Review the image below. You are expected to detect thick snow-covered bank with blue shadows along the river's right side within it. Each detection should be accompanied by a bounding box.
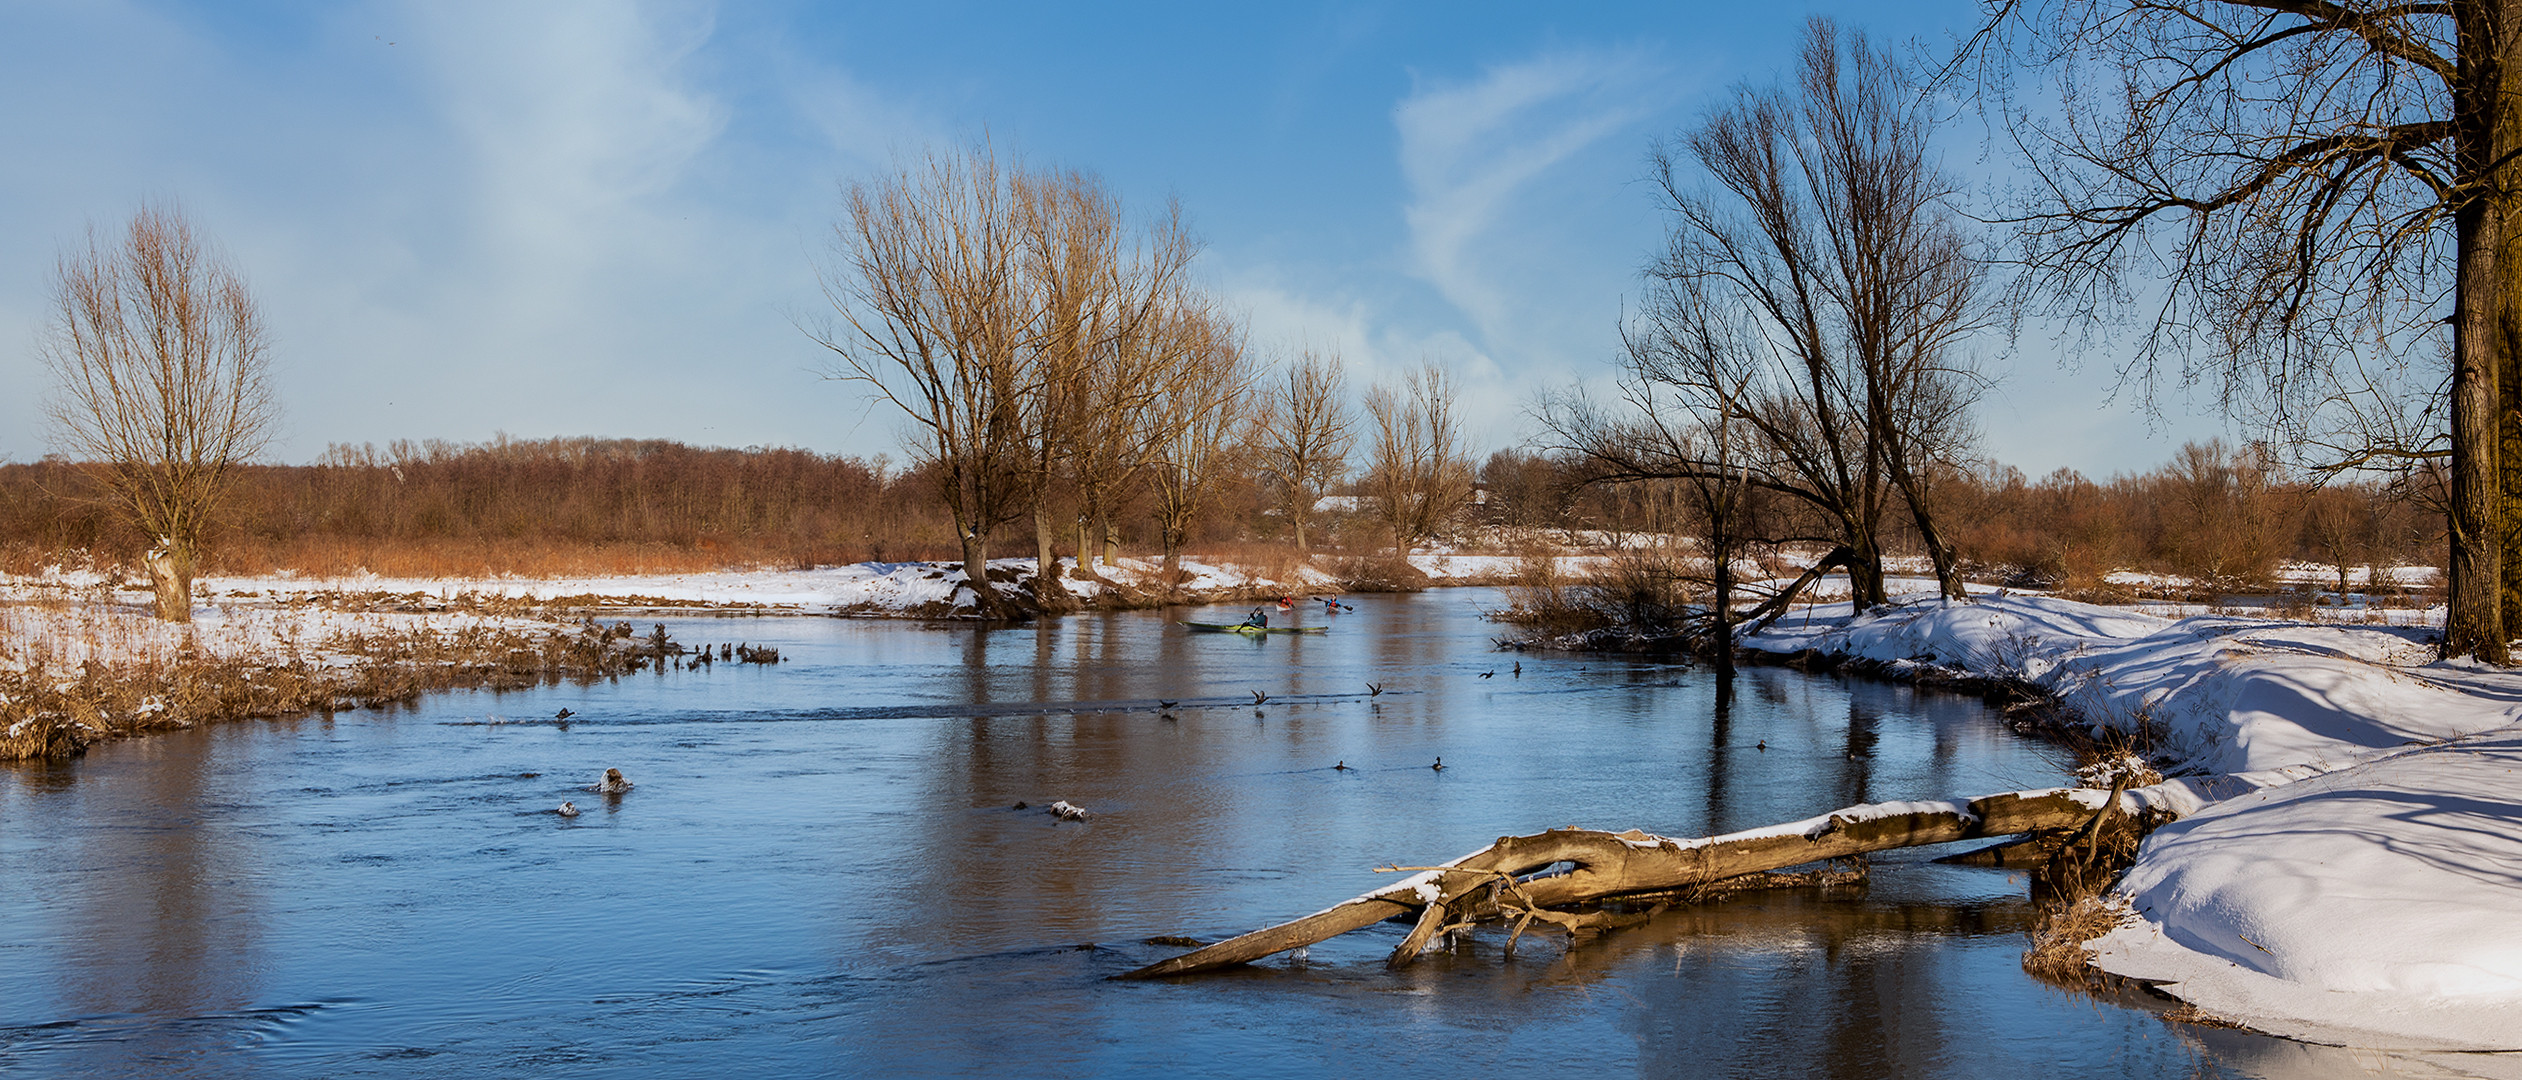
[1745,596,2522,1050]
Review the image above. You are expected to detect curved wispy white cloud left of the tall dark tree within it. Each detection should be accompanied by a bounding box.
[1392,50,1672,346]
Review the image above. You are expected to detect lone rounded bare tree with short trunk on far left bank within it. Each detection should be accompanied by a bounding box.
[40,204,280,623]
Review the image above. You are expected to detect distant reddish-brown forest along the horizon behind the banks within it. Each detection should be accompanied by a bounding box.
[0,439,2444,590]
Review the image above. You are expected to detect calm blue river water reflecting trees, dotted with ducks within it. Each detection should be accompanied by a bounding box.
[0,590,2371,1080]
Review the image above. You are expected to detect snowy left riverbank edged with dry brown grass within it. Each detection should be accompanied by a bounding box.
[0,553,1518,762]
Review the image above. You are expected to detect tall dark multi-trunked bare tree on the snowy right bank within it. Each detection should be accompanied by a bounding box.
[1593,20,1985,608]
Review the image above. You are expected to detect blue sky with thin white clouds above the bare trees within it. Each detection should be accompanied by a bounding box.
[0,0,2219,474]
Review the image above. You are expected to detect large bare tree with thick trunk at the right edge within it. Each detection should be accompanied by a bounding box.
[1975,0,2522,664]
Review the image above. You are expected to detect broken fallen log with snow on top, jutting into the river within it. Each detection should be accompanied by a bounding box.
[1117,785,2192,979]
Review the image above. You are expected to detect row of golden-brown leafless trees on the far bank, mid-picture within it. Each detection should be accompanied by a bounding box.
[812,144,1470,616]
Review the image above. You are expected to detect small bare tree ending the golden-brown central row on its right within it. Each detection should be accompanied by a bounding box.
[1364,361,1470,558]
